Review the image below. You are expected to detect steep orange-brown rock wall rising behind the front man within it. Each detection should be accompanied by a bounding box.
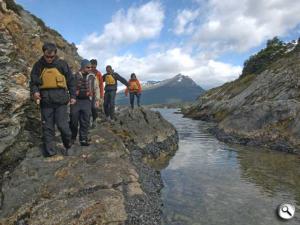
[0,0,80,154]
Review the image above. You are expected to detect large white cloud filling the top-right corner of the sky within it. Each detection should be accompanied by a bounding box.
[185,0,300,52]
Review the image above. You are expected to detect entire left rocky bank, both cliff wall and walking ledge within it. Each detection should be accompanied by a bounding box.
[0,0,178,225]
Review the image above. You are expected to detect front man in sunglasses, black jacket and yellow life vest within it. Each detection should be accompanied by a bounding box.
[30,42,76,157]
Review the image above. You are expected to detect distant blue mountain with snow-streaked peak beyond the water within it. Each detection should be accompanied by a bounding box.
[116,74,204,105]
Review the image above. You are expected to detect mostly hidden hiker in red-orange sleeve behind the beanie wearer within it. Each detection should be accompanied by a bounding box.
[90,59,104,128]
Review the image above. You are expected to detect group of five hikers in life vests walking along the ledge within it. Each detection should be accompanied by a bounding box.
[30,42,142,157]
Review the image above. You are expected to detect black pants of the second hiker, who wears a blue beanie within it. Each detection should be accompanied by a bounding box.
[70,99,91,141]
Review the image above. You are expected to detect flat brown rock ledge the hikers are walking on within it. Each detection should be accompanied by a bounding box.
[0,108,178,225]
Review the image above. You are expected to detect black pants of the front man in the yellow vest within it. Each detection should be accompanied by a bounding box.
[41,105,71,156]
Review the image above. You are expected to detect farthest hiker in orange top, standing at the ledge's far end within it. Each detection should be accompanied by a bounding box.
[125,73,142,109]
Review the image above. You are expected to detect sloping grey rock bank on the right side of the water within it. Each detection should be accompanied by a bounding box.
[183,40,300,153]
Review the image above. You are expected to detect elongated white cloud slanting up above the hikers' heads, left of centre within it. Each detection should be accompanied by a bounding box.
[77,1,164,58]
